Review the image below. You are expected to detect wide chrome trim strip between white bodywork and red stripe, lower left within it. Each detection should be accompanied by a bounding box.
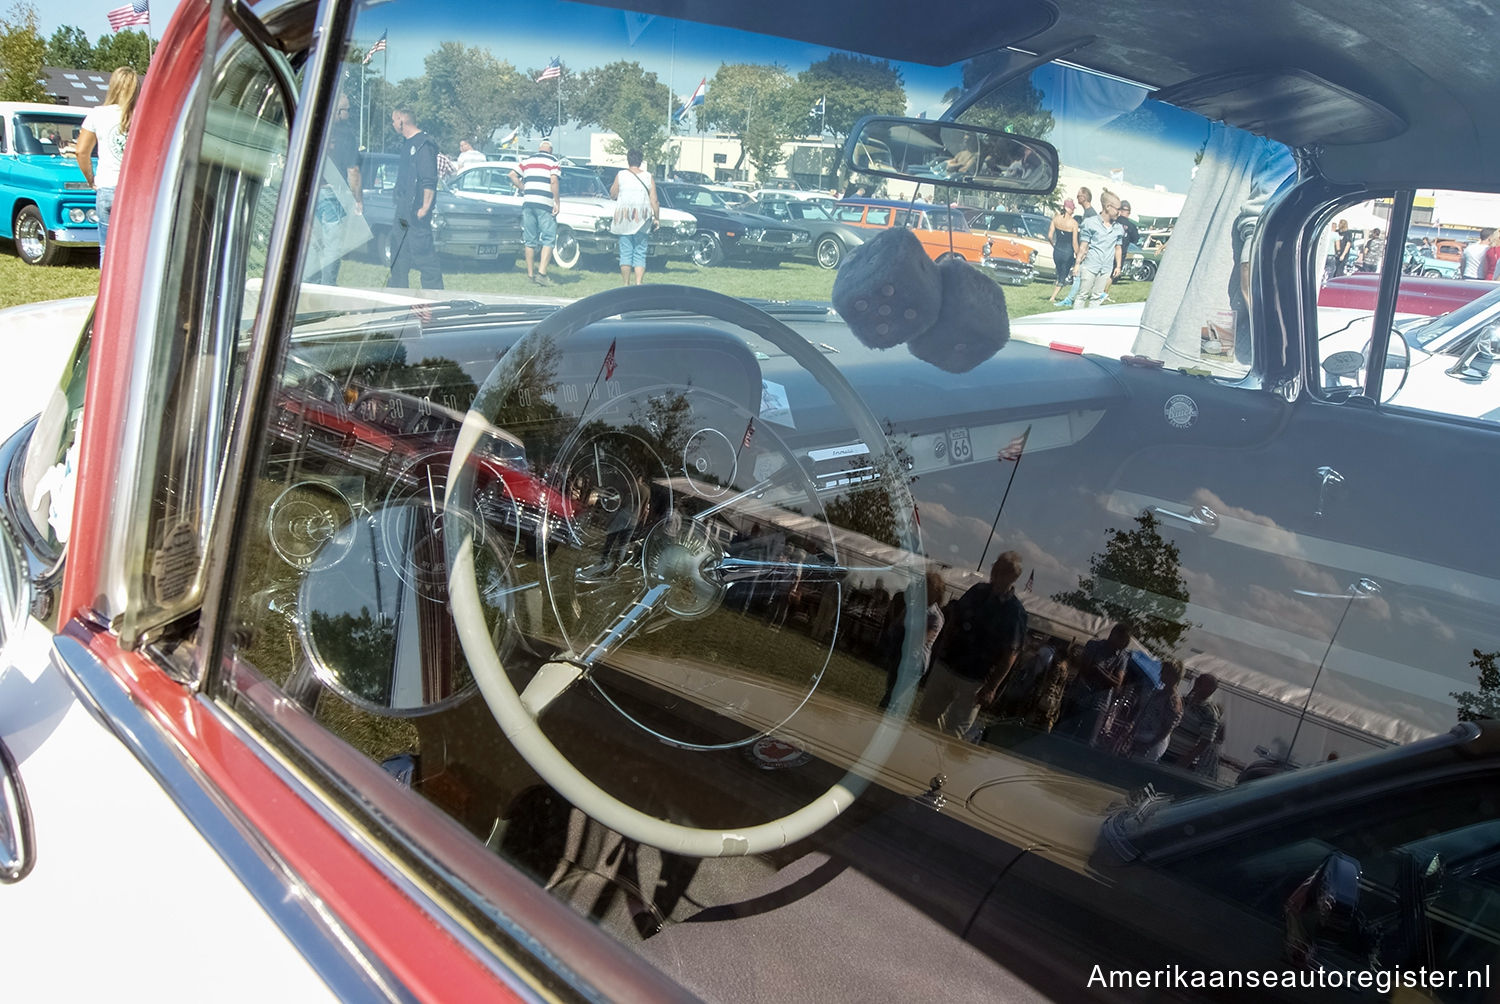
[51,636,417,1001]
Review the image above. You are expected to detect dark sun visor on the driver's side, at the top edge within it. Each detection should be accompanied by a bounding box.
[579,0,1058,66]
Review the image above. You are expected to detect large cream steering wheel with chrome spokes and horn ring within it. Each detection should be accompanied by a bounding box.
[434,285,926,857]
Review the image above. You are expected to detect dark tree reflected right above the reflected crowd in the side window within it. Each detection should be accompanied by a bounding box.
[1052,512,1191,656]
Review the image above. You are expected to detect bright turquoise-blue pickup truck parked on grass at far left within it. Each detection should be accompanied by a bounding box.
[0,102,99,266]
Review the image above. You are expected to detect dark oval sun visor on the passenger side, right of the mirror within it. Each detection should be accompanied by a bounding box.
[1152,69,1407,147]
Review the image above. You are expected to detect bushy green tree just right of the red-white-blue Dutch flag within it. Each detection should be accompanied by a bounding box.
[699,63,812,182]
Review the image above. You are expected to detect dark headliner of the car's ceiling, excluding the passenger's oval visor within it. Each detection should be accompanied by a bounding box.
[582,0,1500,191]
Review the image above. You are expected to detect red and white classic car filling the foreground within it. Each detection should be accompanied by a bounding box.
[0,0,1500,1002]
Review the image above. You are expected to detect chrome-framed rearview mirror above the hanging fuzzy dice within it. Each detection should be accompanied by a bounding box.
[843,116,1058,195]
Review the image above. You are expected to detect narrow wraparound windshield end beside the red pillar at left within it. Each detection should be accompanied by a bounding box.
[102,41,297,644]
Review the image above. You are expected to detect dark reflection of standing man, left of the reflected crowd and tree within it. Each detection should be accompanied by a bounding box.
[918,551,1026,738]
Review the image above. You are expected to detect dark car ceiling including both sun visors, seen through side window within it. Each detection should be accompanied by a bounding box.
[582,0,1476,191]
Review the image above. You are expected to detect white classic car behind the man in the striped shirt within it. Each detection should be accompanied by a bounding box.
[447,164,698,269]
